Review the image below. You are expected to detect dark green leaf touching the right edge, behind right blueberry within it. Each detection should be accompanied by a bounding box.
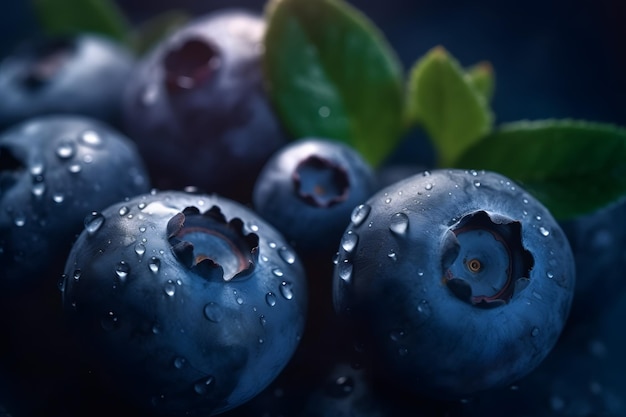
[450,120,626,219]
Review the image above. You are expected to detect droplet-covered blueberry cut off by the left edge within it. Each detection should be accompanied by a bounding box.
[0,115,150,292]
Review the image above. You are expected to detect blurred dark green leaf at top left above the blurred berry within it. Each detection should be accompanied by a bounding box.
[32,0,130,42]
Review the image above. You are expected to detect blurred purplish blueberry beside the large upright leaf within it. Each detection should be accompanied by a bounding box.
[123,9,285,204]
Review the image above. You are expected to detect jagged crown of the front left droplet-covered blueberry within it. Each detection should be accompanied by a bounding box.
[167,206,259,281]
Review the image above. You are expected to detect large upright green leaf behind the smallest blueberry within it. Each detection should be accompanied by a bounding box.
[264,0,405,165]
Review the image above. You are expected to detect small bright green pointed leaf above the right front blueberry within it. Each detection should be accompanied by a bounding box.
[408,46,493,167]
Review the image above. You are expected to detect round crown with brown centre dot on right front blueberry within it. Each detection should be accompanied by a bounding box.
[443,210,534,308]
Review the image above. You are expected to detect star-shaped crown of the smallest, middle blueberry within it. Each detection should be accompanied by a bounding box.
[292,155,350,207]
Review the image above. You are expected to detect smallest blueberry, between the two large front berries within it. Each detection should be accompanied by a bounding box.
[252,138,376,255]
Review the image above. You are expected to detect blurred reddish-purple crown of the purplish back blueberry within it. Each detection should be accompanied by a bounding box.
[163,38,220,94]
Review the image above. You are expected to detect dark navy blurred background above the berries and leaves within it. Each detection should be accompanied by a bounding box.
[0,0,626,125]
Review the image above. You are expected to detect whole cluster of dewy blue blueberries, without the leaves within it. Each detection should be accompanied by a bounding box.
[0,6,626,417]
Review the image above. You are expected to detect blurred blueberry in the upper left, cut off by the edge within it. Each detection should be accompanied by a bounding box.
[0,34,135,129]
